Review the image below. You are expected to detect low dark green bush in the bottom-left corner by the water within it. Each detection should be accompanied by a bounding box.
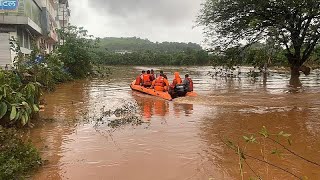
[0,126,42,180]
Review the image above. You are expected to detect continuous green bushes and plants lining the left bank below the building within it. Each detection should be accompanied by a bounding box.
[0,26,103,179]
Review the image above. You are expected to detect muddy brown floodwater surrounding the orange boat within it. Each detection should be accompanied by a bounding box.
[29,67,320,180]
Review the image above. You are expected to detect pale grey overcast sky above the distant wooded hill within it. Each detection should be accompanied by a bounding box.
[69,0,204,43]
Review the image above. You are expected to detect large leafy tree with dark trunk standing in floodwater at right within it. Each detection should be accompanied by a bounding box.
[197,0,320,82]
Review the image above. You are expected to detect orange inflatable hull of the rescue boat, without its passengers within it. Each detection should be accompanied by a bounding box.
[130,81,197,101]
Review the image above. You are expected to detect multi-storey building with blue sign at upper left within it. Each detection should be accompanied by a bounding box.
[0,0,70,68]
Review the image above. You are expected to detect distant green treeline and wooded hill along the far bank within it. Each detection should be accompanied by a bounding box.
[92,37,320,67]
